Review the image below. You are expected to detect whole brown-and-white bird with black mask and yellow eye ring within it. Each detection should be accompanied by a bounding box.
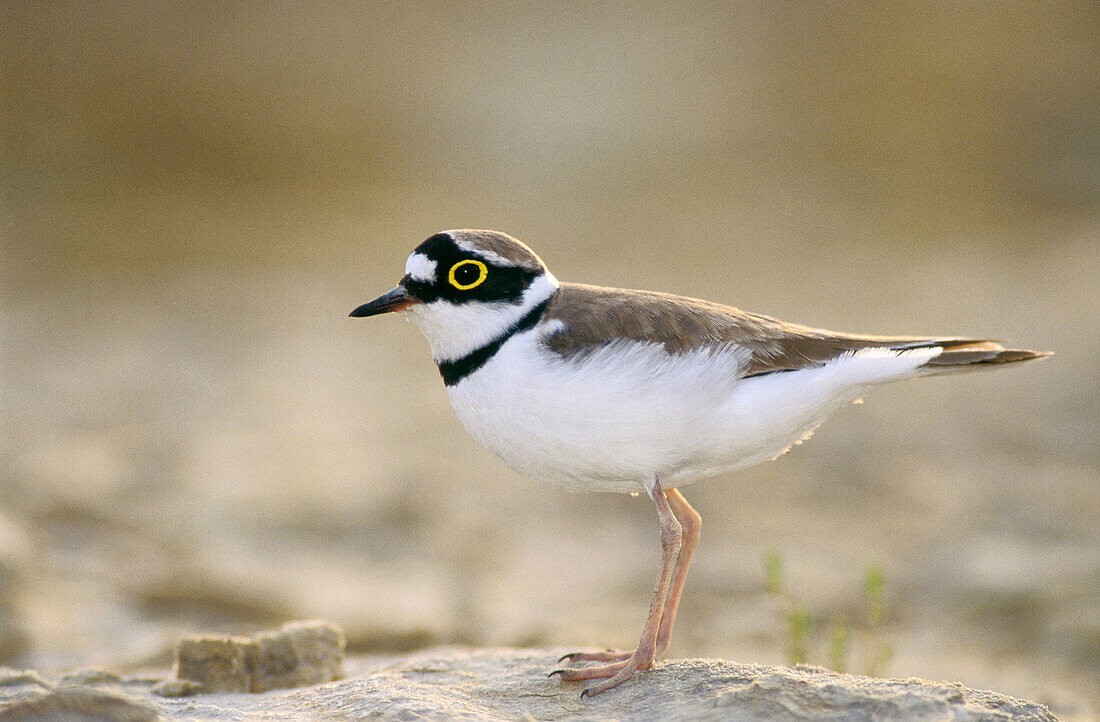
[350,230,1051,698]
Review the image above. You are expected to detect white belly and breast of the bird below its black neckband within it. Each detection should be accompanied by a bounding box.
[448,334,942,492]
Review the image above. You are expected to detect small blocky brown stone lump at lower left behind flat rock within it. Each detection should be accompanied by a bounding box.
[172,621,344,692]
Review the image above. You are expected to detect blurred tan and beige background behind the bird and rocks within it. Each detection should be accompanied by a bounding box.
[0,2,1100,719]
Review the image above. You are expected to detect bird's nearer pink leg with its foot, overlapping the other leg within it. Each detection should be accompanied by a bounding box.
[550,488,683,698]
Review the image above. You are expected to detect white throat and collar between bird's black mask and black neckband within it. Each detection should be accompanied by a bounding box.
[408,273,558,362]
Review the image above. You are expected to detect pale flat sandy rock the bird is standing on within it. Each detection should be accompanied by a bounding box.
[0,649,1055,722]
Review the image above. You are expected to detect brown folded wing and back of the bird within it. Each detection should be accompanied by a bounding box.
[543,283,1001,376]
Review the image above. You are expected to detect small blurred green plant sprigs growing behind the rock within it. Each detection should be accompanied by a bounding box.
[763,550,893,677]
